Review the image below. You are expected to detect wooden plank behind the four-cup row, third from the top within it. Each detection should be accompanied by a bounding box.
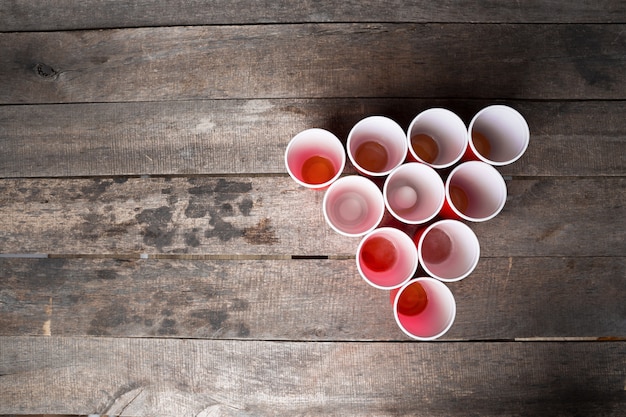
[0,99,626,178]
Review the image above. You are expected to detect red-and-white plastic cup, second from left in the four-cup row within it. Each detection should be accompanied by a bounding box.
[347,116,407,177]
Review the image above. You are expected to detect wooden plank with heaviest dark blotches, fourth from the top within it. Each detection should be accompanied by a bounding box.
[0,177,626,257]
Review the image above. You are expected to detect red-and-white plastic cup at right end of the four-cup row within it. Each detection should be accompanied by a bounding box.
[465,105,530,166]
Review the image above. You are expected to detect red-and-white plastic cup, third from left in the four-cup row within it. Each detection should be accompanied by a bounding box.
[406,108,467,169]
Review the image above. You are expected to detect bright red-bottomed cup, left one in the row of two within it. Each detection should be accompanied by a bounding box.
[356,227,418,290]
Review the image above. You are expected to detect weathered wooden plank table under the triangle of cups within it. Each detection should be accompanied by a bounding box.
[0,0,626,416]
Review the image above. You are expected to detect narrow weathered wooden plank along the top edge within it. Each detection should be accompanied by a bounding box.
[0,0,626,31]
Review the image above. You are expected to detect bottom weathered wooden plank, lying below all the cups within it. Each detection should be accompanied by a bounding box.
[0,337,626,416]
